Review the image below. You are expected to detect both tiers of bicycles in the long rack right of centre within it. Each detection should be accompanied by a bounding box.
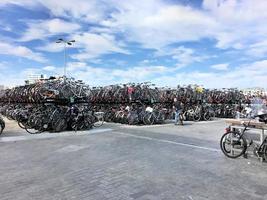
[89,82,253,124]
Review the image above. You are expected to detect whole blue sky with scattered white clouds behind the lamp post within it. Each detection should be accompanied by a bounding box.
[0,0,267,88]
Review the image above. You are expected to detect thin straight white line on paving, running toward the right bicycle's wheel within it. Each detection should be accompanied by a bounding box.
[114,131,221,152]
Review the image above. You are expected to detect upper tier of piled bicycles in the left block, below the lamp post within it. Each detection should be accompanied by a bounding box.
[0,77,90,103]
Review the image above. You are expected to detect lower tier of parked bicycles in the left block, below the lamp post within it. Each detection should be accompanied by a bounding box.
[1,103,103,134]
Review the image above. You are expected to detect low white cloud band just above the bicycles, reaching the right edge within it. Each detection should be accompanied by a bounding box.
[152,60,267,88]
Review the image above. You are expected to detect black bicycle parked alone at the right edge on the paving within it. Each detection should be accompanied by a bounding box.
[220,120,267,161]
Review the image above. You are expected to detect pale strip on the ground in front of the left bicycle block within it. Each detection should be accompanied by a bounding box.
[0,128,113,142]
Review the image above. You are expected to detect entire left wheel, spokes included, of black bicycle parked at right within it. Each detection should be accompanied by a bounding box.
[220,131,247,158]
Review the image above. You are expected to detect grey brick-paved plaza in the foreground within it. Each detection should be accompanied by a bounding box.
[0,120,267,200]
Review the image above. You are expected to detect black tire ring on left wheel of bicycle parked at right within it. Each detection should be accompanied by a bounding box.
[220,131,247,159]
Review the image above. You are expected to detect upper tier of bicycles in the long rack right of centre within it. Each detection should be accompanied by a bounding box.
[89,82,253,105]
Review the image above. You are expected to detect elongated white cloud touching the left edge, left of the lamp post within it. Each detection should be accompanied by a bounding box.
[0,42,47,62]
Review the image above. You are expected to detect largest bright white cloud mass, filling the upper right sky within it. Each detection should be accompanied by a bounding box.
[103,0,267,53]
